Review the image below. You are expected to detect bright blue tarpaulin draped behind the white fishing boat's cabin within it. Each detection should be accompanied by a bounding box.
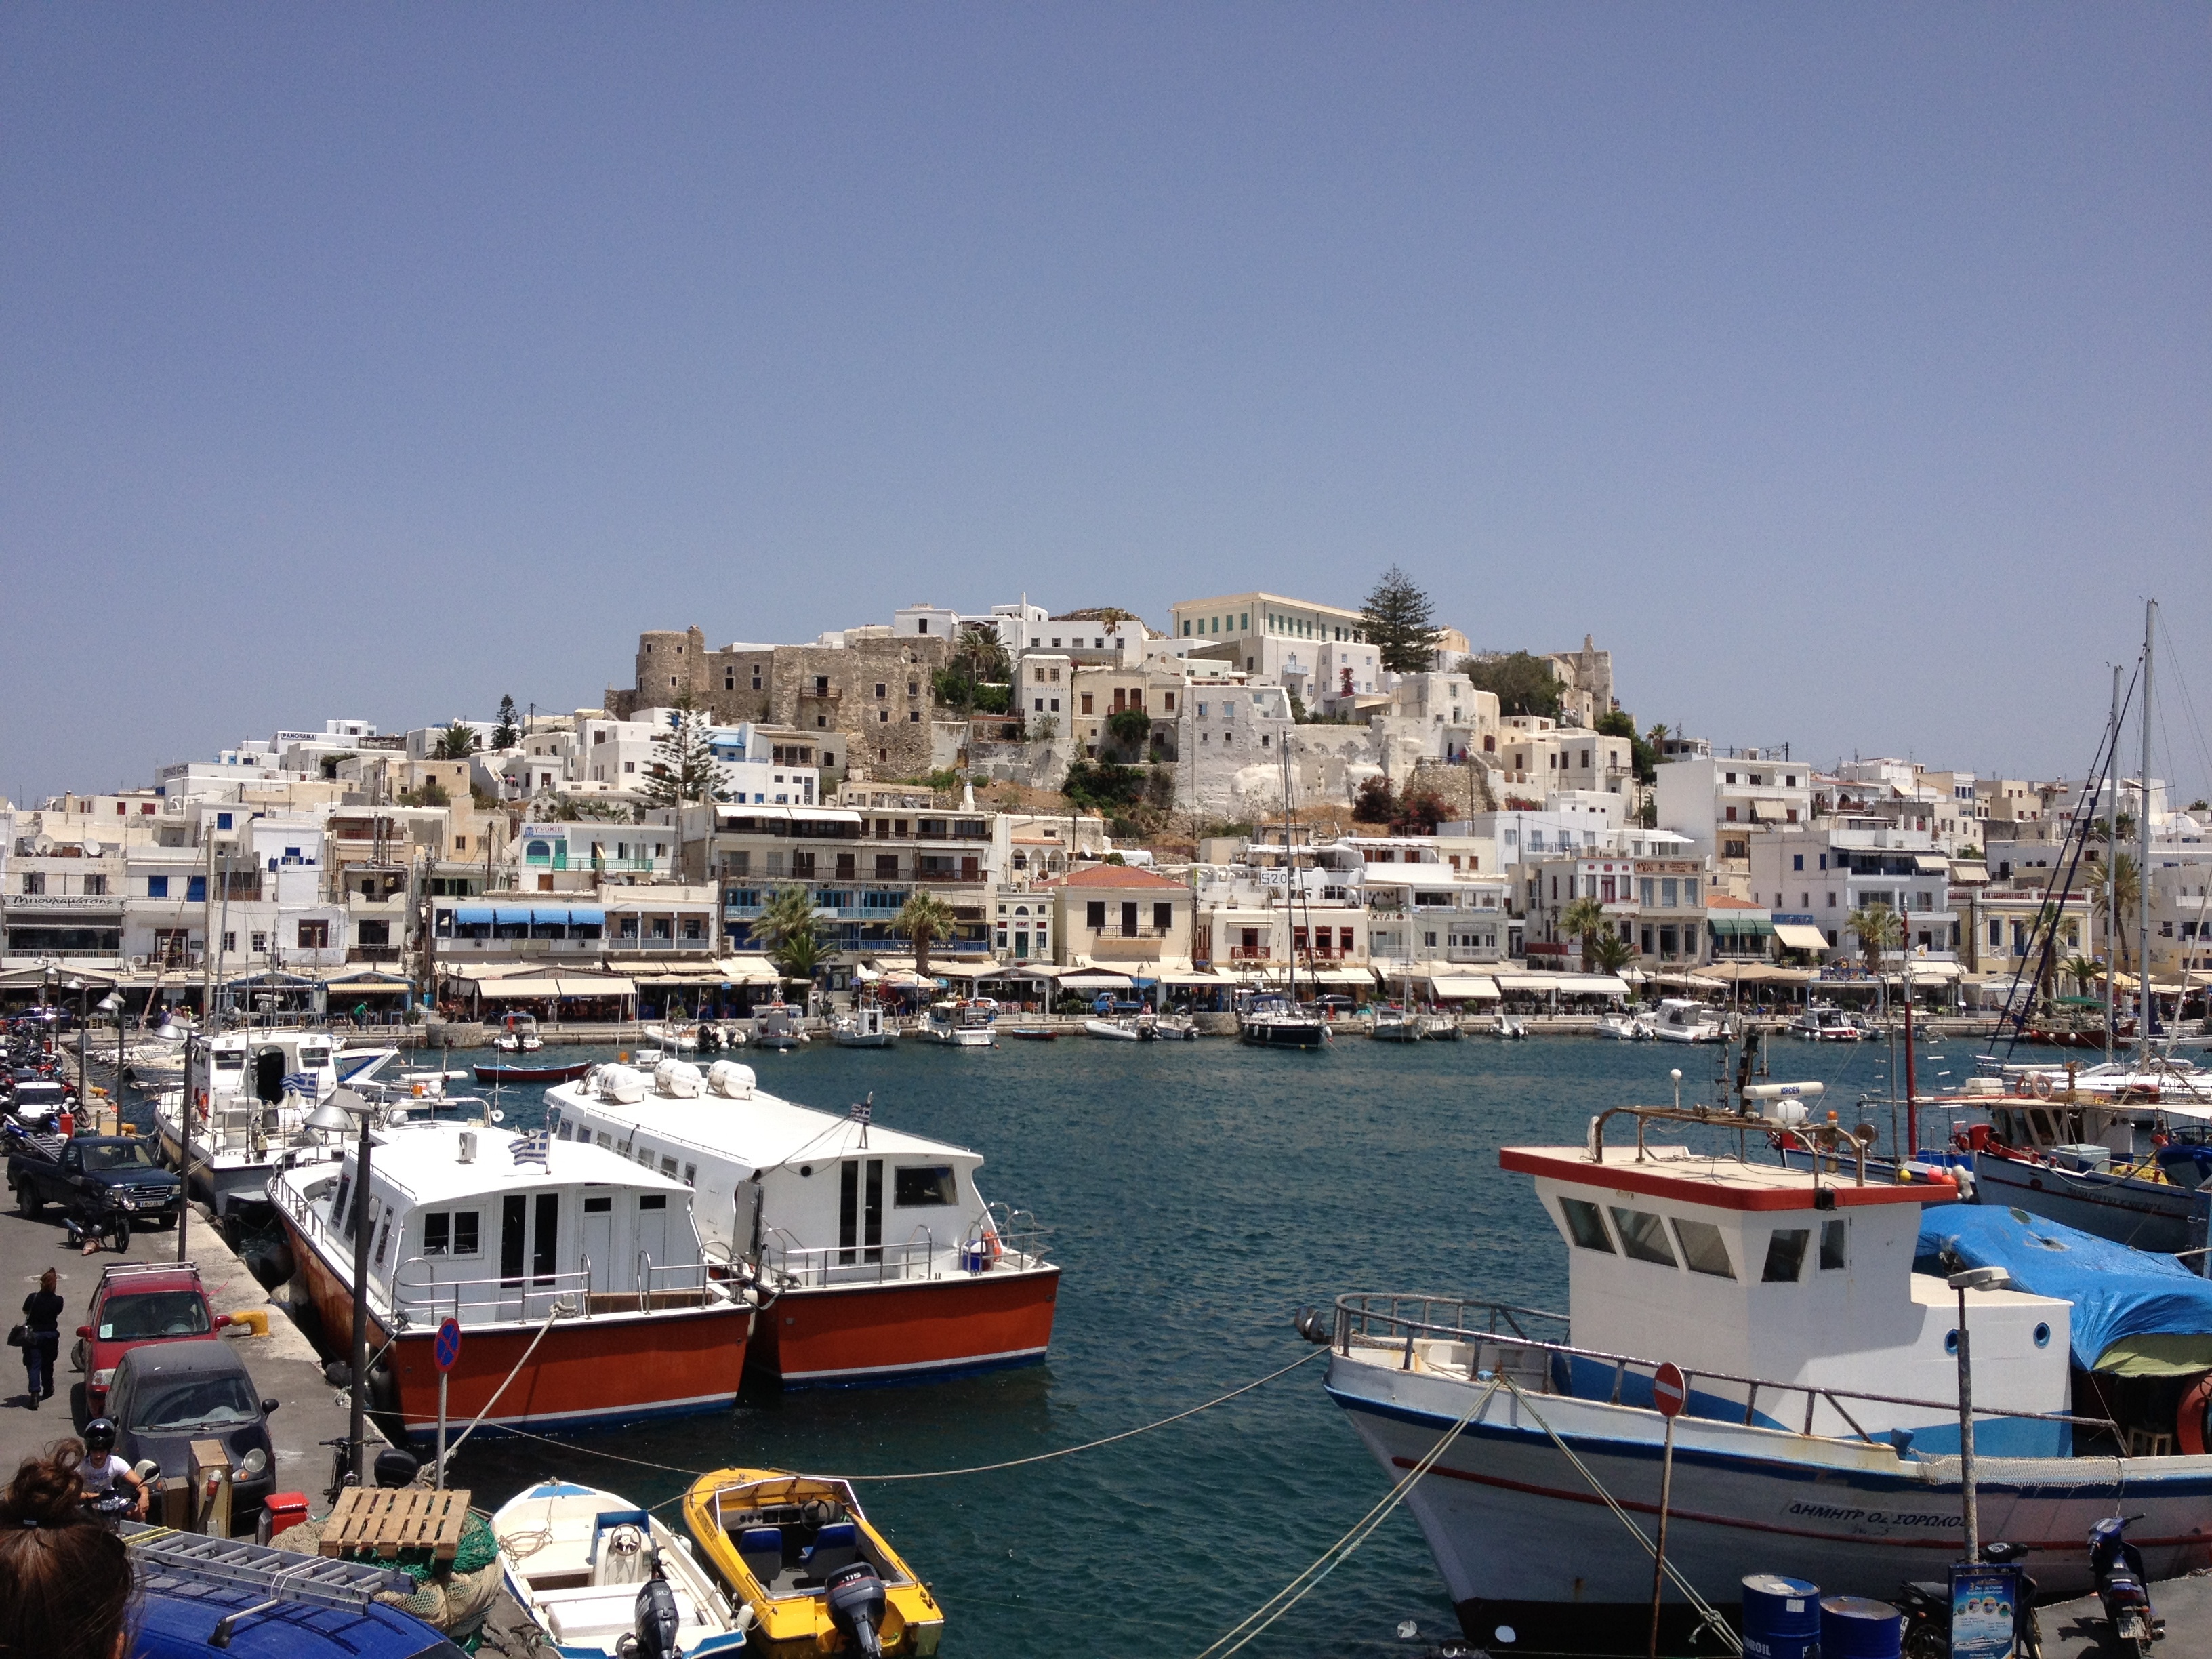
[1918,1204,2212,1376]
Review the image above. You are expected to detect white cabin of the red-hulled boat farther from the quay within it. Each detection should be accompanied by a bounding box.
[546,1059,1017,1288]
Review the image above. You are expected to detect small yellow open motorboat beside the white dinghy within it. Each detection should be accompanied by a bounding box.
[684,1469,945,1659]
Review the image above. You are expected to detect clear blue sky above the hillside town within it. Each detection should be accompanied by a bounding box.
[0,5,2212,801]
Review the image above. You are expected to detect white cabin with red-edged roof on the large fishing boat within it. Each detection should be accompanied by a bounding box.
[1500,1146,2072,1456]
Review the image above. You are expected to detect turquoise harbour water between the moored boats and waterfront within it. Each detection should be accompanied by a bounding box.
[298,1038,1880,1659]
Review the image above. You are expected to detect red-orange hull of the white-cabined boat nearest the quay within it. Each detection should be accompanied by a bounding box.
[285,1218,752,1433]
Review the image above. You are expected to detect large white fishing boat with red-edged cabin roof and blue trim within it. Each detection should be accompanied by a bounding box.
[1323,1108,2212,1652]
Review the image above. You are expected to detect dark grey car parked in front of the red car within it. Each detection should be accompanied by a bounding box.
[108,1343,276,1533]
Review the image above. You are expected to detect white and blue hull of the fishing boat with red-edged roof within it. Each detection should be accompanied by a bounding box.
[1327,1356,2212,1654]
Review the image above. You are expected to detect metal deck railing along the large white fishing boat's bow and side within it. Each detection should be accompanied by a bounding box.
[1332,1292,2119,1444]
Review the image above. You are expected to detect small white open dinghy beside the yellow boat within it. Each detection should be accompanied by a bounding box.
[491,1480,752,1659]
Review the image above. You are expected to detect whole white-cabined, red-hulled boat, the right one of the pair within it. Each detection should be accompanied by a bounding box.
[546,1059,1059,1387]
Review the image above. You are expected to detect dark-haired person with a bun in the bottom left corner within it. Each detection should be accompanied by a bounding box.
[0,1440,131,1659]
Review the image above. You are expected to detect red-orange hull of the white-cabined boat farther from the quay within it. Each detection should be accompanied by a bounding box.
[752,1267,1059,1382]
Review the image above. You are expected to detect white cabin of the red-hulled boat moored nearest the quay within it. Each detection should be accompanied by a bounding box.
[291,1122,705,1325]
